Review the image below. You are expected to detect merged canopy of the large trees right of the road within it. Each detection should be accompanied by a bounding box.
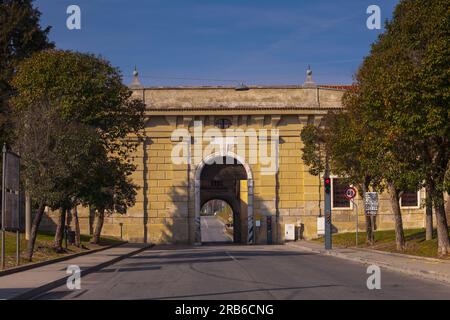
[304,0,450,255]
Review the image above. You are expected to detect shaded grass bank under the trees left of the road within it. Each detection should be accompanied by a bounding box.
[0,232,122,268]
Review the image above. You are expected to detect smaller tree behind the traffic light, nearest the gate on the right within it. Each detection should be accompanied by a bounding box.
[302,83,421,250]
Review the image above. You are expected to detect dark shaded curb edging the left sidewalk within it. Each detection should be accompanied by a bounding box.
[9,244,154,300]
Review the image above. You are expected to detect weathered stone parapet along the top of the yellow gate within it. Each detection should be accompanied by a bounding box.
[132,85,351,110]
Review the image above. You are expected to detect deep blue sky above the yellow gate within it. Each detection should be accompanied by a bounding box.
[35,0,398,86]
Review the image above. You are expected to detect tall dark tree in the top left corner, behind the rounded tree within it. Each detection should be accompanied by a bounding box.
[0,0,53,145]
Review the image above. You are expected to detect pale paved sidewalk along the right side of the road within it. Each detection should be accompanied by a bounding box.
[287,241,450,284]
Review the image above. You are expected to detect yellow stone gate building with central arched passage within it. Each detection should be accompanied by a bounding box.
[40,72,425,244]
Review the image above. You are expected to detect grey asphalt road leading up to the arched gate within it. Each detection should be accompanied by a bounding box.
[39,245,450,300]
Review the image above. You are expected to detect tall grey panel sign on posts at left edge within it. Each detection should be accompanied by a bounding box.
[1,144,20,269]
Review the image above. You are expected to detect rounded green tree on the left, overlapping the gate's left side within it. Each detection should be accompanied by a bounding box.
[11,50,145,257]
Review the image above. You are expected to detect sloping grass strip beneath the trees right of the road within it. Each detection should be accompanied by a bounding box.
[314,229,450,259]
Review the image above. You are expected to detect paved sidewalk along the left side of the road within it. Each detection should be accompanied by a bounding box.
[0,243,151,300]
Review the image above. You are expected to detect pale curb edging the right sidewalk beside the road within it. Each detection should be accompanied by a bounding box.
[293,245,450,284]
